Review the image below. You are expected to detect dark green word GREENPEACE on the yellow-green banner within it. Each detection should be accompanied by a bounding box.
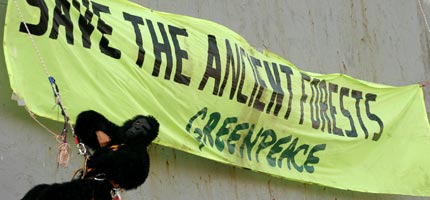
[185,107,326,173]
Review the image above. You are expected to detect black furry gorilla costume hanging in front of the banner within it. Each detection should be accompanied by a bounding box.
[23,110,159,200]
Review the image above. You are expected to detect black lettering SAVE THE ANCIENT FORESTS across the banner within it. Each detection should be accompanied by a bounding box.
[19,0,384,141]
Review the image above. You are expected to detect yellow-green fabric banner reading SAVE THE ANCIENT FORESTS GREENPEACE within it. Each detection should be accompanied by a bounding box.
[4,0,430,196]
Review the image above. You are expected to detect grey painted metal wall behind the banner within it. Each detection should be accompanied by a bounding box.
[0,0,430,200]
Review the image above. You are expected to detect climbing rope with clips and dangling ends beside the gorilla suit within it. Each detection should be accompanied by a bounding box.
[13,0,89,167]
